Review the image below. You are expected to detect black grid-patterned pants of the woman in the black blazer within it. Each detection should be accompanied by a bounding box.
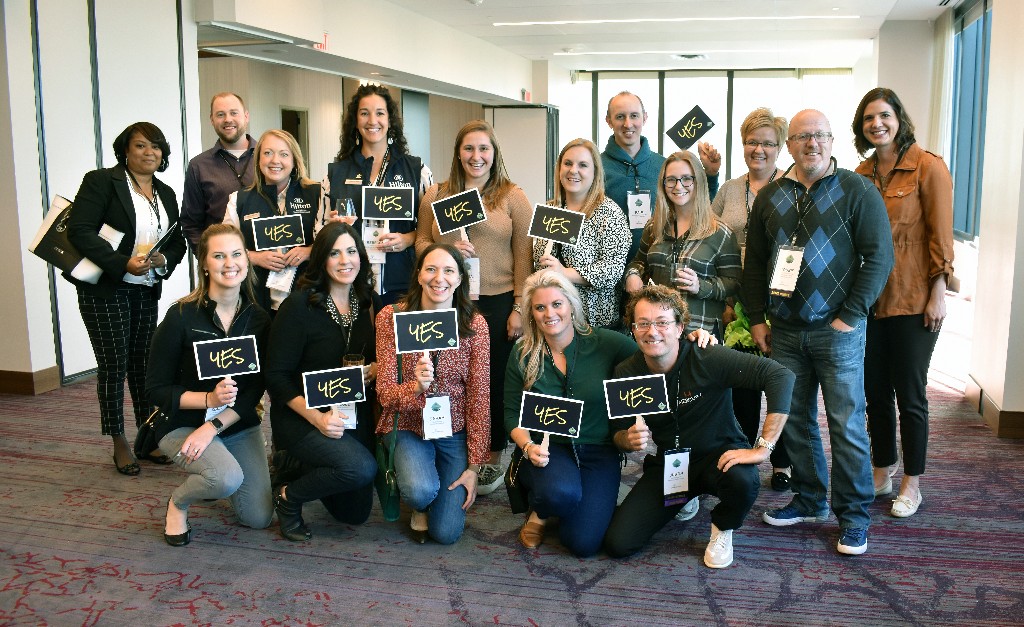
[78,283,157,435]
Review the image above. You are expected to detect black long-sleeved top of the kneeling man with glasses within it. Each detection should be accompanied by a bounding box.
[611,338,797,459]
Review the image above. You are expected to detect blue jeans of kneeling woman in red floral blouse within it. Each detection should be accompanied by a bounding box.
[394,429,469,544]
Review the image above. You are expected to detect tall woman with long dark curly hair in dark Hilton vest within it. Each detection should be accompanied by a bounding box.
[318,85,434,304]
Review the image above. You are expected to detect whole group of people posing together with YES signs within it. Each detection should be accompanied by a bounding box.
[69,80,952,568]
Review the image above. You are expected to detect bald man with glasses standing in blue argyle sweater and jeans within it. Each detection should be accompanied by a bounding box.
[742,110,893,555]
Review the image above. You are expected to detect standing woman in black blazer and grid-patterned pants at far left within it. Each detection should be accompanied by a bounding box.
[65,122,185,474]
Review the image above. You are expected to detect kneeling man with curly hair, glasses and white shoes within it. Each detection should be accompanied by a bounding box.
[604,285,795,569]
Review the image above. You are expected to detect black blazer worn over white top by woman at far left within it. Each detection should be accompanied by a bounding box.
[65,165,185,298]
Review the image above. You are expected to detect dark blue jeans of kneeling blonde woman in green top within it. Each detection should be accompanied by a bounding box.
[519,444,620,557]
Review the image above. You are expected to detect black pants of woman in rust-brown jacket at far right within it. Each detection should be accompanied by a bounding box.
[864,314,939,476]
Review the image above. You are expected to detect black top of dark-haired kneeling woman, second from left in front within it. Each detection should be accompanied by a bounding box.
[265,290,383,450]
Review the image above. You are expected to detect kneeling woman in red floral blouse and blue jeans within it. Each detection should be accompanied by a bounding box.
[377,244,490,544]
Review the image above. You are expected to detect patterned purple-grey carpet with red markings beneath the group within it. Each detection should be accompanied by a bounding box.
[0,381,1024,625]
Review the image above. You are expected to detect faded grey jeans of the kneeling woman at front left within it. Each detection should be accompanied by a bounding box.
[160,426,273,529]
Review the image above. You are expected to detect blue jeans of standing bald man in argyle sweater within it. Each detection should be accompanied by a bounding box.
[771,323,874,529]
